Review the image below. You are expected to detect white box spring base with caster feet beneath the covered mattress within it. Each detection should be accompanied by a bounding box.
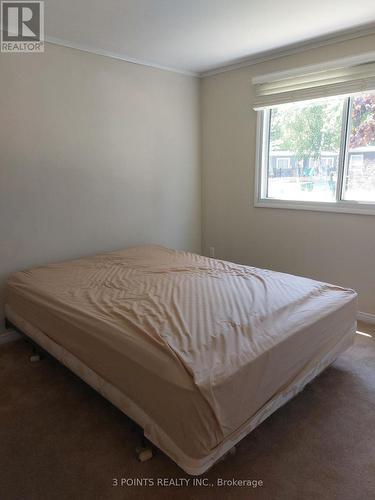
[5,306,356,475]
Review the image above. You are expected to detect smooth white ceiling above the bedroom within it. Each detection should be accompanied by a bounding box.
[45,0,375,74]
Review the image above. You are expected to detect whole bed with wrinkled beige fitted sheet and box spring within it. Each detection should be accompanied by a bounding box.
[5,245,357,475]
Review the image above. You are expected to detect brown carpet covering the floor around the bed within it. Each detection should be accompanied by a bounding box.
[0,324,375,500]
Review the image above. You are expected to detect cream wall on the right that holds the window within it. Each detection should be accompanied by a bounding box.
[201,36,375,314]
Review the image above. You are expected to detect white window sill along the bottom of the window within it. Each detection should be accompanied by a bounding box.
[254,198,375,215]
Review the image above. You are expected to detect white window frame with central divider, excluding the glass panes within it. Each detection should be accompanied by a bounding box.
[254,95,375,215]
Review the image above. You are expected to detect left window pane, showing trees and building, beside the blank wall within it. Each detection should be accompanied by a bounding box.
[267,97,345,201]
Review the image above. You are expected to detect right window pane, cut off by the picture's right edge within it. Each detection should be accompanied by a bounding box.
[343,93,375,201]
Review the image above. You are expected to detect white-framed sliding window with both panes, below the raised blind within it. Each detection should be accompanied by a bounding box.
[256,92,375,214]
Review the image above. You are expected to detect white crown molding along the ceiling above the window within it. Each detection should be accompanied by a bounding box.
[199,23,375,78]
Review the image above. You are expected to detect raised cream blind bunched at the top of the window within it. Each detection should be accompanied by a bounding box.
[253,62,375,110]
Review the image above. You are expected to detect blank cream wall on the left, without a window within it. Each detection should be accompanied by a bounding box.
[0,44,201,330]
